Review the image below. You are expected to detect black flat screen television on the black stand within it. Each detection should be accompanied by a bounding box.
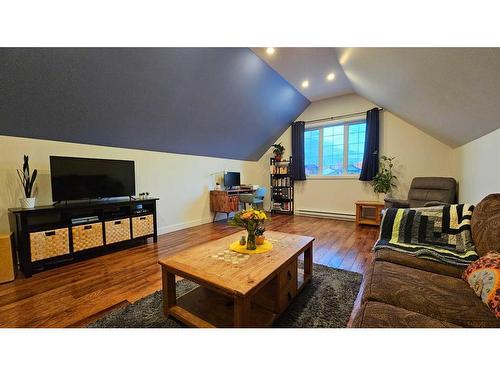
[50,156,135,201]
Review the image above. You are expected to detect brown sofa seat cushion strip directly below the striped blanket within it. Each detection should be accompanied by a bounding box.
[375,249,466,278]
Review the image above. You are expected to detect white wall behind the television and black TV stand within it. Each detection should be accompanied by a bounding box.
[0,136,260,233]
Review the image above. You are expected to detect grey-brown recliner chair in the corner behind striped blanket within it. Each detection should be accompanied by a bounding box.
[384,177,457,208]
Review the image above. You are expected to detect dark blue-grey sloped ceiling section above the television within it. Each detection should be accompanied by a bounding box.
[0,48,310,160]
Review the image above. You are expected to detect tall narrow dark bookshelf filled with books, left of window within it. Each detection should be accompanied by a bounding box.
[270,156,294,215]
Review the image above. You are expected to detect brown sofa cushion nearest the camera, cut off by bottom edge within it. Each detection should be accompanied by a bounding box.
[352,301,460,328]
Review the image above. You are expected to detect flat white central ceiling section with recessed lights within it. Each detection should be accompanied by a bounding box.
[252,48,354,101]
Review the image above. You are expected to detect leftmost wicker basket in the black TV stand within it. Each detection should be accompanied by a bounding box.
[30,228,69,262]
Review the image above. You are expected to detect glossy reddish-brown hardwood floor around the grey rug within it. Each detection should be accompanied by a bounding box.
[0,215,378,327]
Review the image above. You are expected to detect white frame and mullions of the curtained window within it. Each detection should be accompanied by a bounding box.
[305,118,366,180]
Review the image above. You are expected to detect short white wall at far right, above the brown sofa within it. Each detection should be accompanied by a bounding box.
[453,129,500,204]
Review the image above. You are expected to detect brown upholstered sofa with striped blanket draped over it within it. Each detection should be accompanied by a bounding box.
[352,194,500,328]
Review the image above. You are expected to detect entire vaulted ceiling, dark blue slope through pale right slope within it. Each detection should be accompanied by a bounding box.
[0,48,500,160]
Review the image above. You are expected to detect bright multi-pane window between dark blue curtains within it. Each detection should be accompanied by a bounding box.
[304,122,366,176]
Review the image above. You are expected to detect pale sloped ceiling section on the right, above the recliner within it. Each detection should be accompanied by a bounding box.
[336,48,500,147]
